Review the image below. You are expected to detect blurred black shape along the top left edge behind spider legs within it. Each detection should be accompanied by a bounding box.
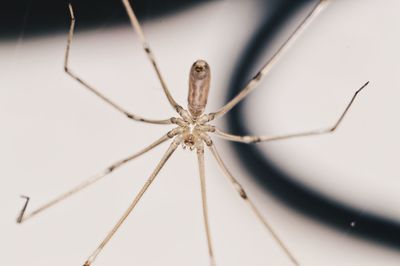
[0,0,210,38]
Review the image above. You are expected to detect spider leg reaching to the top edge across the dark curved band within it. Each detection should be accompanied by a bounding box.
[209,0,329,119]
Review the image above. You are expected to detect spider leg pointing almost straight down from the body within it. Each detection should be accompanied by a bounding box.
[197,145,216,266]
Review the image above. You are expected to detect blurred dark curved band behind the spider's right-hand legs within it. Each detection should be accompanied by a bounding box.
[227,0,400,249]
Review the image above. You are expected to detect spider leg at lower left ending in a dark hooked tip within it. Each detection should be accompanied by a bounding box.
[17,134,171,223]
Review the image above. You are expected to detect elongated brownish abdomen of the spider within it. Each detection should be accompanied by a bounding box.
[188,60,211,118]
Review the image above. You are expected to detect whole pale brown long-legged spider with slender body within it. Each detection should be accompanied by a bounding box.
[17,0,368,266]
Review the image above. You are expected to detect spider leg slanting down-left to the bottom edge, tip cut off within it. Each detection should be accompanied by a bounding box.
[84,136,181,266]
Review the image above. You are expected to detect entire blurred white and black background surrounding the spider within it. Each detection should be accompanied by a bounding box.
[0,0,400,266]
